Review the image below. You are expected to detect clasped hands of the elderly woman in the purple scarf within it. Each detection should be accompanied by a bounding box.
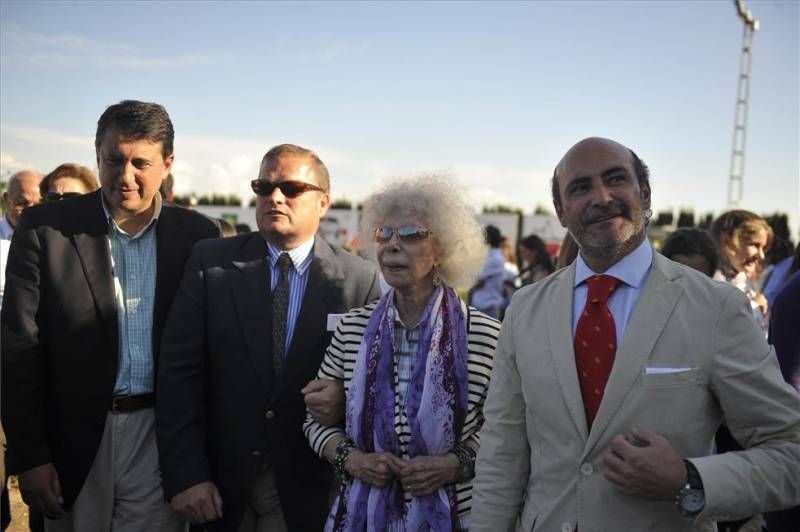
[344,449,458,497]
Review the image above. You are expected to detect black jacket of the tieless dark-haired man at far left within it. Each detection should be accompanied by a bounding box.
[0,191,220,509]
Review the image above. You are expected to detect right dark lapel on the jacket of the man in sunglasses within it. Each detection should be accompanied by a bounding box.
[272,237,344,399]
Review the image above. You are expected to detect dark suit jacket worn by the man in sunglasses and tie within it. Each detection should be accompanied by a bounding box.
[156,233,380,532]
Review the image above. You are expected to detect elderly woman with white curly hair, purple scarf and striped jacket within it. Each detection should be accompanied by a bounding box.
[305,175,500,532]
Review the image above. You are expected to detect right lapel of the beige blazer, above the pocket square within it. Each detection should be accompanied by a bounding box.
[579,252,683,457]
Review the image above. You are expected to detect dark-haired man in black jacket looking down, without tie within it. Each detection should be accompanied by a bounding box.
[2,101,219,530]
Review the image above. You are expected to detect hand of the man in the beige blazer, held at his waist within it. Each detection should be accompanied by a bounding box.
[603,429,686,499]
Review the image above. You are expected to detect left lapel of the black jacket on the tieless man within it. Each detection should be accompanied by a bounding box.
[69,190,119,363]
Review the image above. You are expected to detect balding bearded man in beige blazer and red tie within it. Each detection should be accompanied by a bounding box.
[470,138,800,532]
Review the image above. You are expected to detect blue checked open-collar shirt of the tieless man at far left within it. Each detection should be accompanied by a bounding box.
[103,194,161,395]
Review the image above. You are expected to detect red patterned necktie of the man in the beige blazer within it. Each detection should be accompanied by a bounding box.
[575,275,620,428]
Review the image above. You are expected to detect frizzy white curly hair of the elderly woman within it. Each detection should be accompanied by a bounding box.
[361,174,488,288]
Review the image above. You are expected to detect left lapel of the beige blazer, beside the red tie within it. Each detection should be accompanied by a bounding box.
[546,261,588,441]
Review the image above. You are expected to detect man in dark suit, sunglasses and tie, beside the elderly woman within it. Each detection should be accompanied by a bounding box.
[157,144,380,532]
